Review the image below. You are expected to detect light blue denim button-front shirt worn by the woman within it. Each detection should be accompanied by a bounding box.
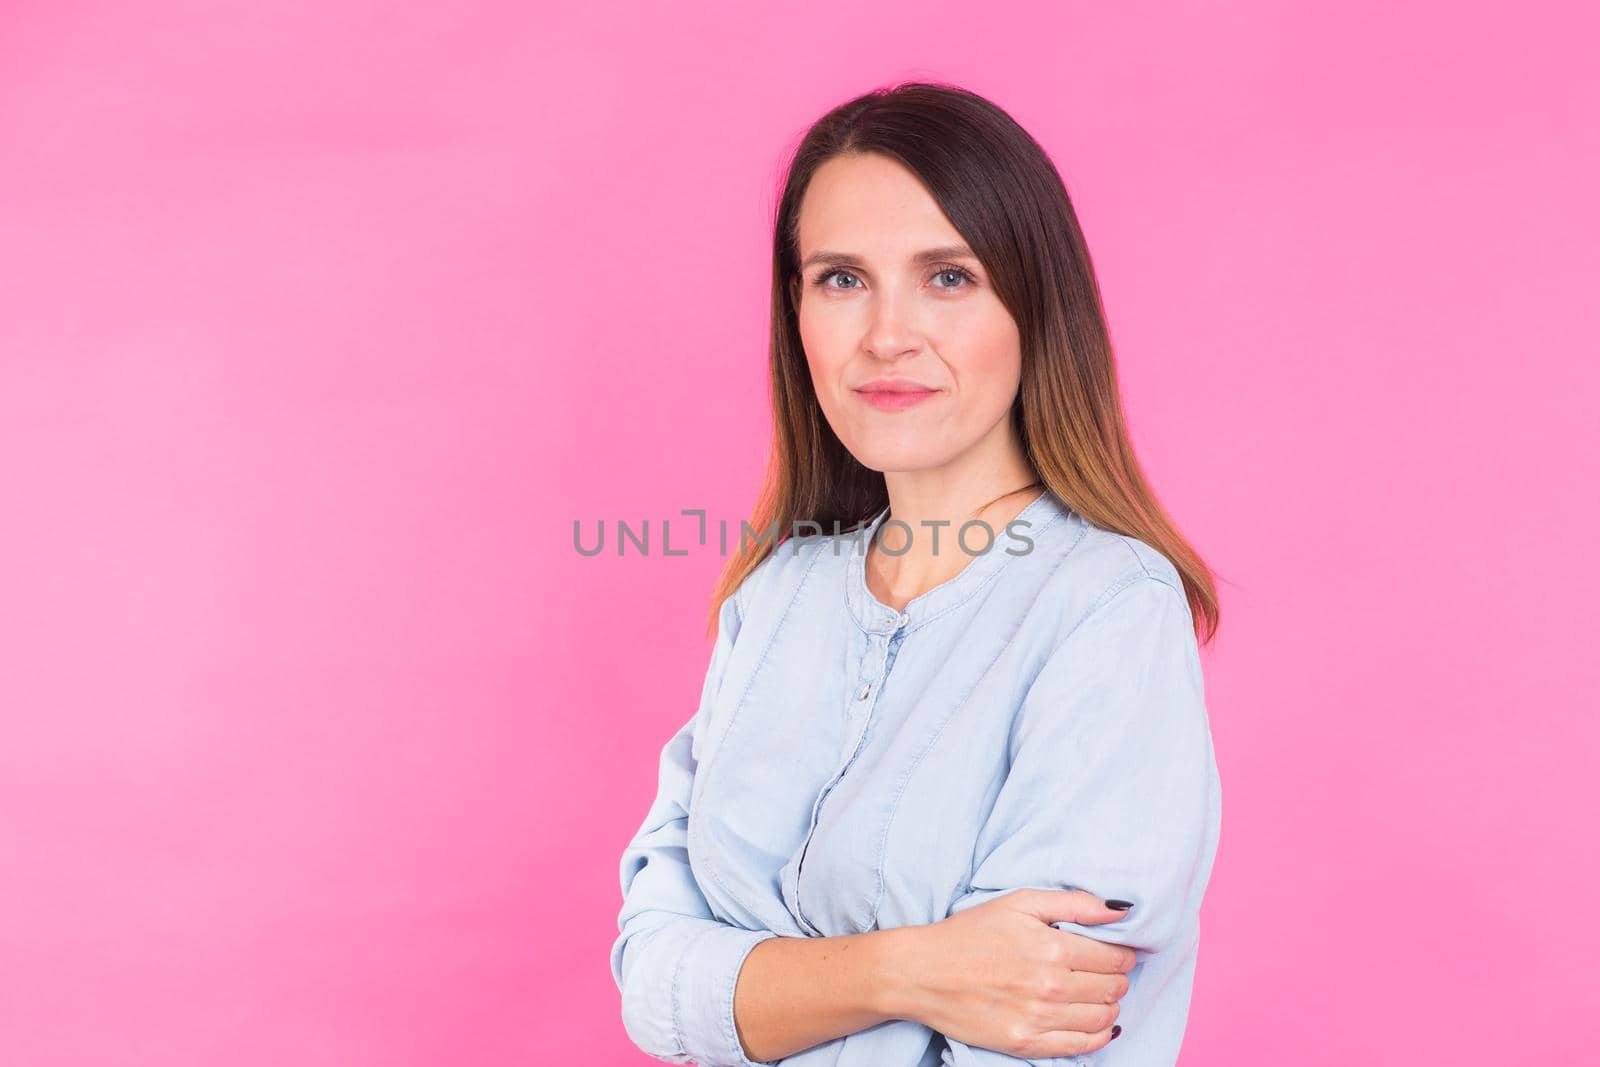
[611,491,1222,1067]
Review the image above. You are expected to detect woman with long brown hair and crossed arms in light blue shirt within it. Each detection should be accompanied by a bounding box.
[611,83,1221,1067]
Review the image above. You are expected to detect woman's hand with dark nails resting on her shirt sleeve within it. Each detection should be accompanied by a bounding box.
[898,889,1136,1059]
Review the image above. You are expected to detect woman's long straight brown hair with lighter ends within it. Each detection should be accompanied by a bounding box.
[709,82,1219,641]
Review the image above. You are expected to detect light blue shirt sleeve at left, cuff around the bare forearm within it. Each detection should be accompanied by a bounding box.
[611,597,778,1067]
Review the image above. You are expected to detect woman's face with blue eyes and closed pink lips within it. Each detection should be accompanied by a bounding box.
[792,155,1022,472]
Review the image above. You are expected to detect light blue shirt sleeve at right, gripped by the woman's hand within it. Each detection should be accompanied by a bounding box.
[949,574,1221,1067]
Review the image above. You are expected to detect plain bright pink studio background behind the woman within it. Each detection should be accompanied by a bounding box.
[0,0,1600,1067]
